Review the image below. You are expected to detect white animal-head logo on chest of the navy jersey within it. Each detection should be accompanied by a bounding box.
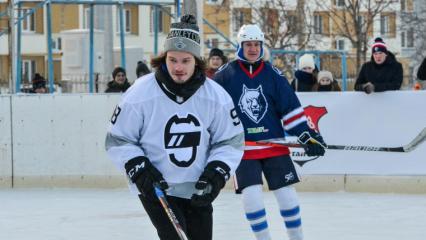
[238,85,268,123]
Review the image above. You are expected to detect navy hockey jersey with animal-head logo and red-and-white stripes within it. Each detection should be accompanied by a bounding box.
[214,60,309,159]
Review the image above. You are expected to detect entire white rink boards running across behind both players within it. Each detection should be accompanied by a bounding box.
[0,91,426,193]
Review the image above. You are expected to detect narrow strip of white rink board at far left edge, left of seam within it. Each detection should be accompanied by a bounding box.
[0,95,12,188]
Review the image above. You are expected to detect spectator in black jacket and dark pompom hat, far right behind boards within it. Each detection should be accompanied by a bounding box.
[355,37,403,94]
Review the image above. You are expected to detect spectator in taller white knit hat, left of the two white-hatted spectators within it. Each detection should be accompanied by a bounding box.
[291,54,318,92]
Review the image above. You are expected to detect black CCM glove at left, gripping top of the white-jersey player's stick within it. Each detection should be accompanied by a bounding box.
[124,156,169,201]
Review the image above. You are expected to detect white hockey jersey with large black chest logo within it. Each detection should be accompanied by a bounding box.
[105,73,244,195]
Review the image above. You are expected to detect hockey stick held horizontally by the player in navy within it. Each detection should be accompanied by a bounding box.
[246,128,426,152]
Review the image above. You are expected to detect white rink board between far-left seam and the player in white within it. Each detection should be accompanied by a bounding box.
[12,95,122,186]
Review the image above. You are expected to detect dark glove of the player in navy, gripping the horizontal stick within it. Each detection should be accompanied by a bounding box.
[297,130,327,157]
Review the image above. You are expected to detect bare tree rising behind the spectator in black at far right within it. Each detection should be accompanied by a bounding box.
[316,0,392,70]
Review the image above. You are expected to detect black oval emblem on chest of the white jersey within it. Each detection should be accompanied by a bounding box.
[164,114,201,167]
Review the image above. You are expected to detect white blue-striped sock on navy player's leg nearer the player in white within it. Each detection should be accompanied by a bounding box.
[242,185,271,240]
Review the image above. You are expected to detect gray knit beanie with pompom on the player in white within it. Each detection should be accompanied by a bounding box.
[164,14,201,58]
